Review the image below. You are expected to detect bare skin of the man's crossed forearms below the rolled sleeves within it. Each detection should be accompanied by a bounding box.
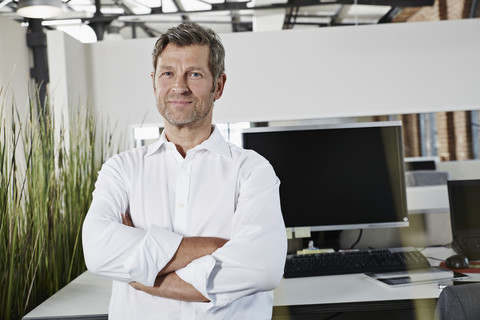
[122,213,227,302]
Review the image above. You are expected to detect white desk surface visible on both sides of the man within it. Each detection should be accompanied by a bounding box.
[23,248,464,320]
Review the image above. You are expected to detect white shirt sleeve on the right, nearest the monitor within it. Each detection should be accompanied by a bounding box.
[177,159,287,310]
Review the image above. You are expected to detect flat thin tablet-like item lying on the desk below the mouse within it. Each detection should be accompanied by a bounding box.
[366,267,468,287]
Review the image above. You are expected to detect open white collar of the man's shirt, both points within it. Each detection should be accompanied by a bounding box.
[144,125,232,158]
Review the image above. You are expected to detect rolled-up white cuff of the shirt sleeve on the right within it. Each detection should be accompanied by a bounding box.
[175,255,227,310]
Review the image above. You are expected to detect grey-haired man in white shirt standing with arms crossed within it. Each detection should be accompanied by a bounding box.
[83,24,286,320]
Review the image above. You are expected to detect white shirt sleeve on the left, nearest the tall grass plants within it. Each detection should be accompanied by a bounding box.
[82,156,182,286]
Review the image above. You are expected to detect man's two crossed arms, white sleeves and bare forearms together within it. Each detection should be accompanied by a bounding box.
[82,158,287,309]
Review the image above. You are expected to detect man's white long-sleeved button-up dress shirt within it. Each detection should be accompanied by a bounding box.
[82,128,287,320]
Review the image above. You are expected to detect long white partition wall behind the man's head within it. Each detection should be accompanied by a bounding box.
[68,19,480,131]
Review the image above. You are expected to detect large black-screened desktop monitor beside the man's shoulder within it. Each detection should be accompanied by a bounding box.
[242,121,408,231]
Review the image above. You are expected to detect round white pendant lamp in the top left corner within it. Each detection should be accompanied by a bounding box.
[17,0,63,19]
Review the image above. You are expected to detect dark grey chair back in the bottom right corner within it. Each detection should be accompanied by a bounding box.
[435,283,480,320]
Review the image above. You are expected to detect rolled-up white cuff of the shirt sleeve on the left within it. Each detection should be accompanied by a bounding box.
[124,225,183,286]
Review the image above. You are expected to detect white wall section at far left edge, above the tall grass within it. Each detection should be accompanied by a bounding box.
[0,16,33,117]
